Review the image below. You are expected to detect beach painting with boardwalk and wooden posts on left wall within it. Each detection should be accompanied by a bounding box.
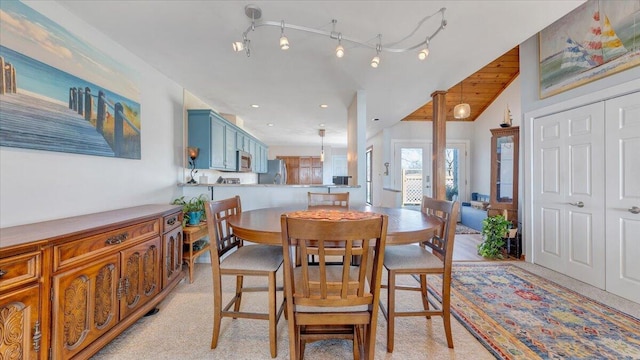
[0,1,141,159]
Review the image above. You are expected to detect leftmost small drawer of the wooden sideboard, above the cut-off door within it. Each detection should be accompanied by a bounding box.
[0,251,40,292]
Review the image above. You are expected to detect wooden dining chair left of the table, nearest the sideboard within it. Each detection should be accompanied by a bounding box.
[205,196,284,358]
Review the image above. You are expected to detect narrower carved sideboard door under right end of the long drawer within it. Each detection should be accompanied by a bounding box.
[120,237,161,319]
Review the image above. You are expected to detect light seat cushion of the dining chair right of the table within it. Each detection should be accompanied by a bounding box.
[384,245,444,270]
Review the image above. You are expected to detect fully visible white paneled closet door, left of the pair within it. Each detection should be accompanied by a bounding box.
[533,103,605,289]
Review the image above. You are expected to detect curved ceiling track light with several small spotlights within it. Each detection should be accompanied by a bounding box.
[233,5,447,68]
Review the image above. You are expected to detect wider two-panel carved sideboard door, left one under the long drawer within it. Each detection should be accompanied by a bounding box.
[52,253,120,359]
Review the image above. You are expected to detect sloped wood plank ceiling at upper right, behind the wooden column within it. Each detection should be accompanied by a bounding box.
[402,46,520,121]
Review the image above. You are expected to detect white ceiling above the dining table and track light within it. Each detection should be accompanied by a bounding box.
[57,0,584,147]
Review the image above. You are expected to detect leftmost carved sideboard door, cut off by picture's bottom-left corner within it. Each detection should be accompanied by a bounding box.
[0,284,42,359]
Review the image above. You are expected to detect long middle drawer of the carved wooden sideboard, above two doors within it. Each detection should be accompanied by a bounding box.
[53,220,160,271]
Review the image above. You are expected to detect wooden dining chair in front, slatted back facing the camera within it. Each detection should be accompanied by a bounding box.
[281,213,388,359]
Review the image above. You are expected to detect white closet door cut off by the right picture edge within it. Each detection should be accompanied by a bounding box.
[606,93,640,303]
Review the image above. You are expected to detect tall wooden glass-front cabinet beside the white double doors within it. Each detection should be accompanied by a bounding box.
[487,126,520,222]
